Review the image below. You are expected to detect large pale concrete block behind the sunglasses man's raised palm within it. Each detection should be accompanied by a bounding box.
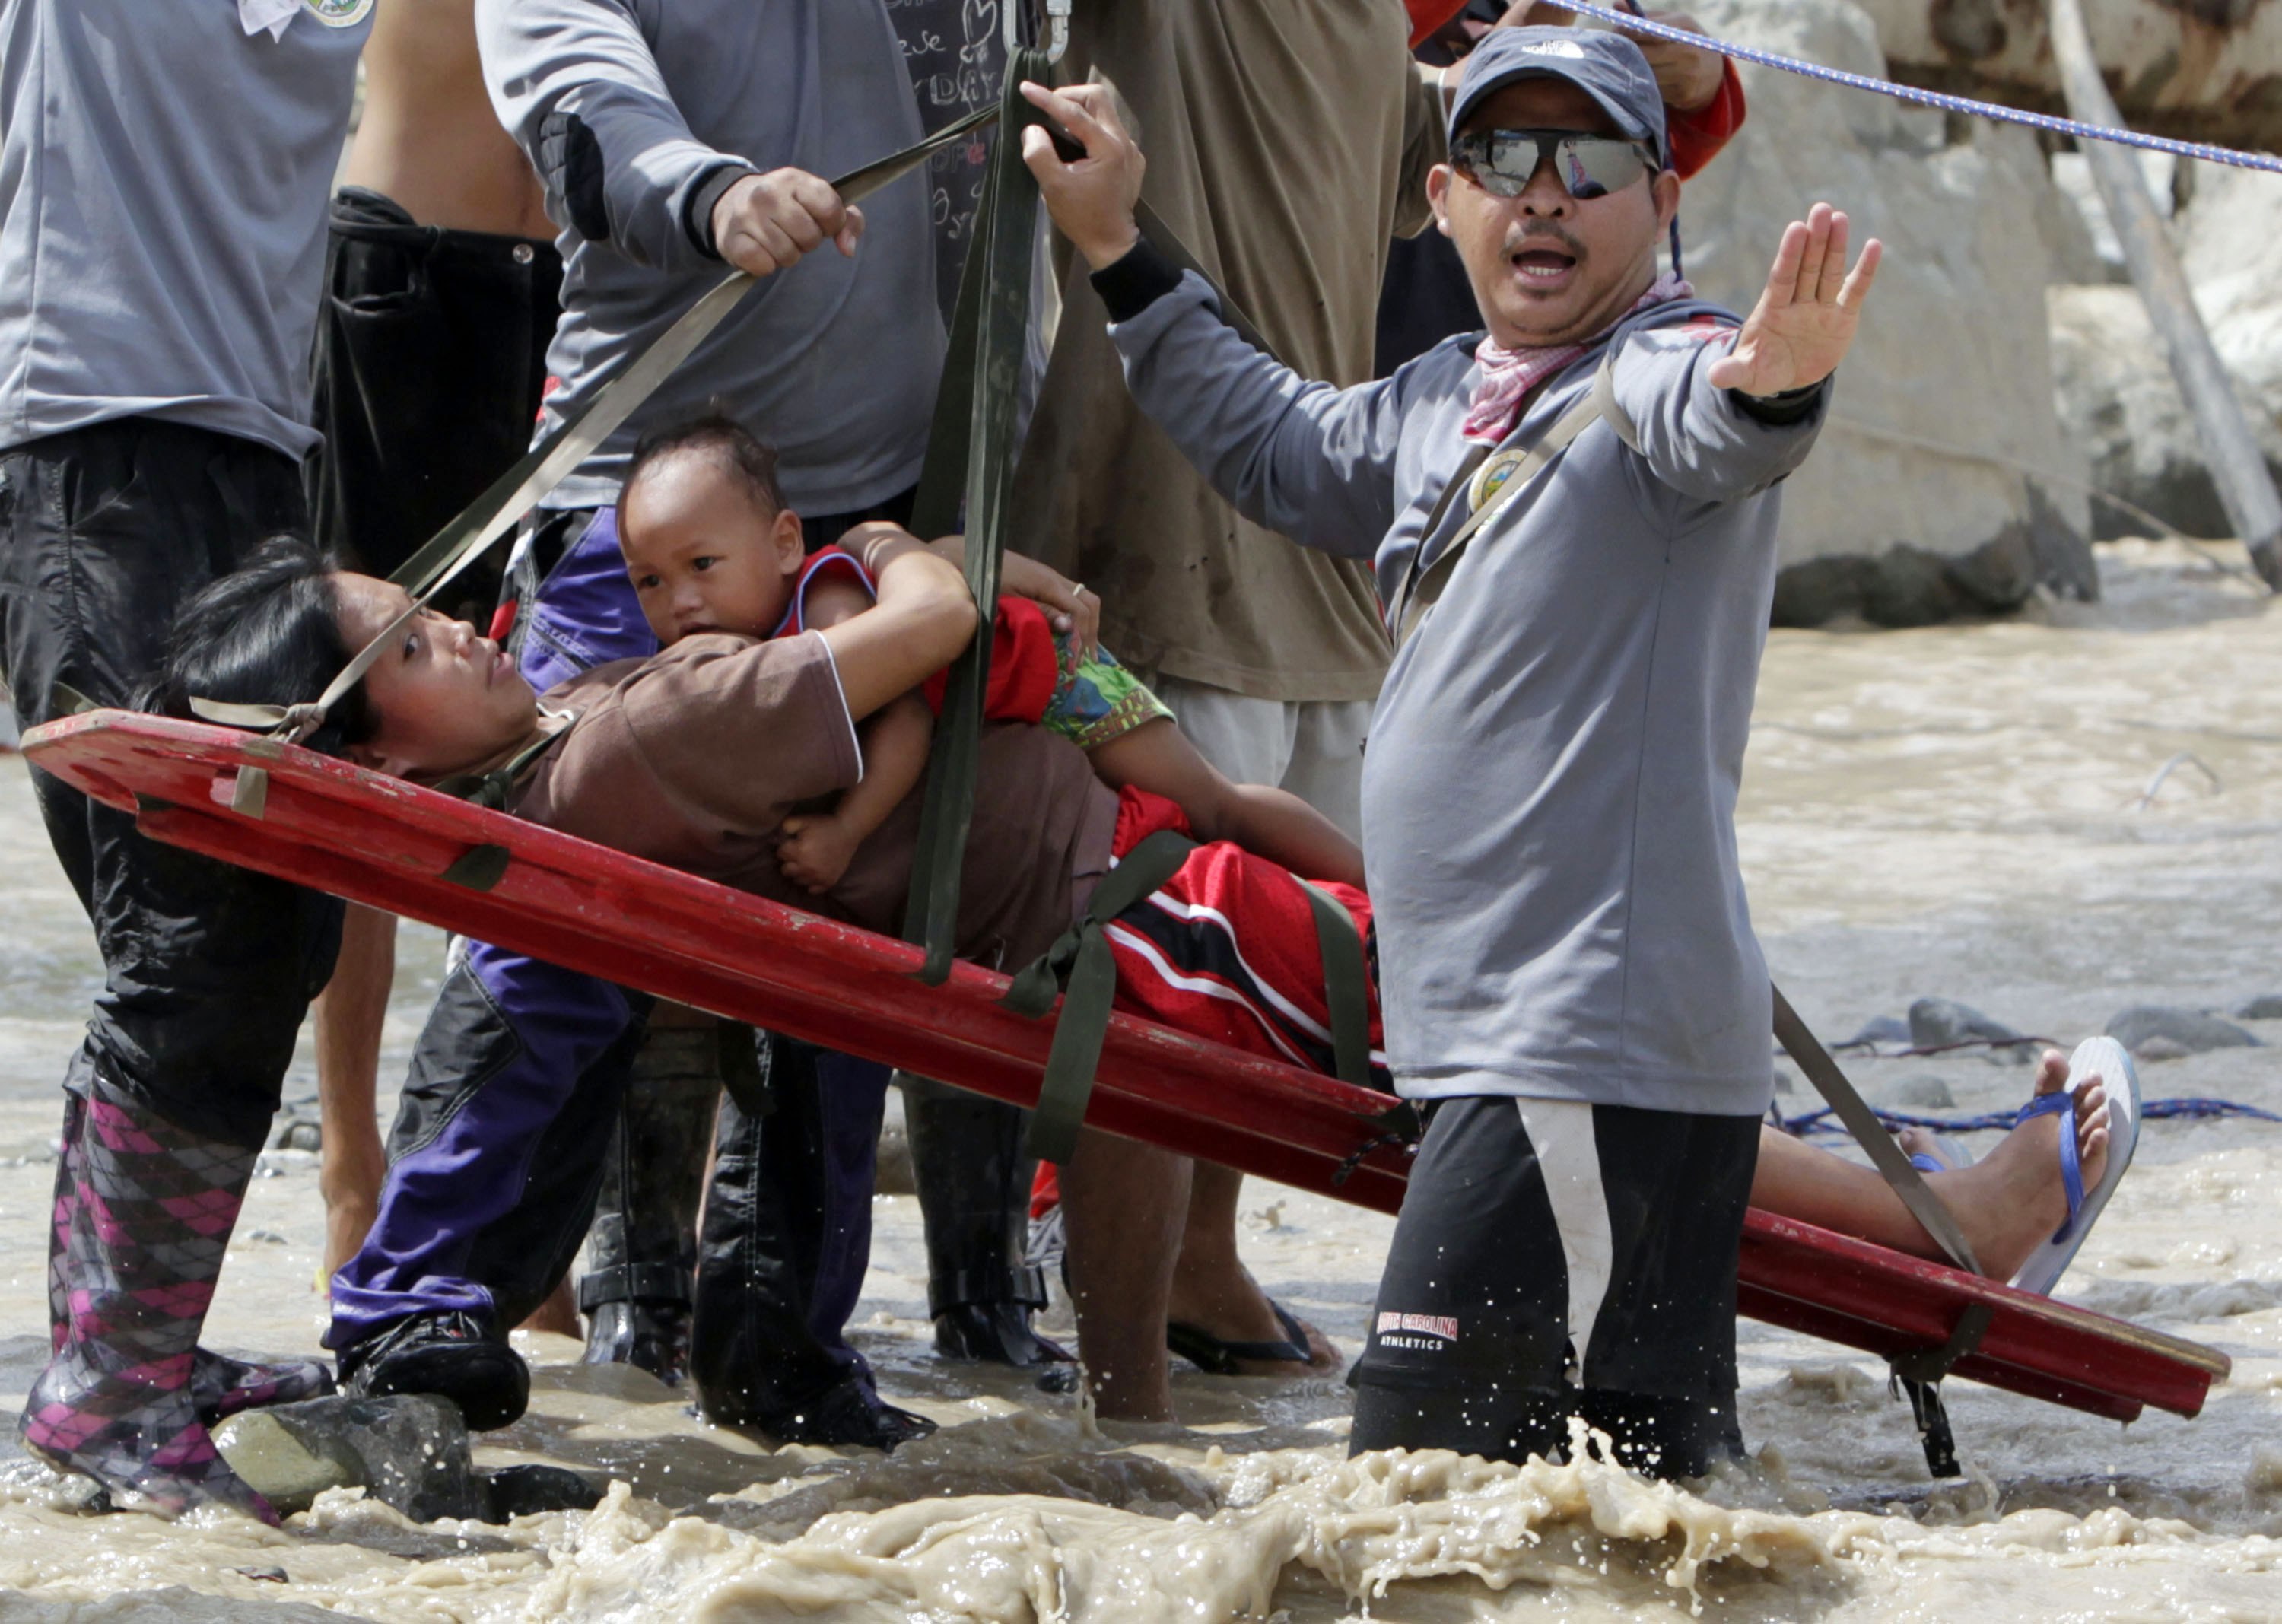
[1680,0,2097,625]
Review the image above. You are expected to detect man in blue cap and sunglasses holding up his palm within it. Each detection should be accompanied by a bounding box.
[1025,27,1878,1476]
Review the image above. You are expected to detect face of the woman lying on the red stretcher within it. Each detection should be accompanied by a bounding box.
[333,570,539,780]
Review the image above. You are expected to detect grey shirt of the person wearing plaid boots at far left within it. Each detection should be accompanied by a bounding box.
[0,0,372,459]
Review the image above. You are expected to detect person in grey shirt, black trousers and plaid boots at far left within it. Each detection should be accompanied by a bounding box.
[0,0,372,1521]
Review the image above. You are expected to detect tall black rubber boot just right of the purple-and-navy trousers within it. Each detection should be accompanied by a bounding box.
[897,1072,1070,1368]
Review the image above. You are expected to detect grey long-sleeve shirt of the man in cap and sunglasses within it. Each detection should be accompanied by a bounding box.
[1111,276,1828,1115]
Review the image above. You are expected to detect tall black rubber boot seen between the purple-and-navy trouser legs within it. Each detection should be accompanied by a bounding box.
[577,1024,721,1384]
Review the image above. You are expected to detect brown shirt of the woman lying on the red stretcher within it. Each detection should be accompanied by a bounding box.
[509,632,1118,965]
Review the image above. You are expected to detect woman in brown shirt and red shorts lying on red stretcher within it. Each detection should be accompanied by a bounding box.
[162,520,2109,1416]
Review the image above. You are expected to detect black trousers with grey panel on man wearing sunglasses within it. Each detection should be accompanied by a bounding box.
[1349,1097,1759,1478]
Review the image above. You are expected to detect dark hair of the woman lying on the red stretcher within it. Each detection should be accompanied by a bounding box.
[144,536,381,755]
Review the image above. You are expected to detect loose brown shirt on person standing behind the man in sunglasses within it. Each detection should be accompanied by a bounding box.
[1011,0,1442,701]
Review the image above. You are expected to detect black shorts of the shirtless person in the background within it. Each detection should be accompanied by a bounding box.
[308,187,564,628]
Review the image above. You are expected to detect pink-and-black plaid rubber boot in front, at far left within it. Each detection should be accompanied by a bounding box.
[18,1079,276,1524]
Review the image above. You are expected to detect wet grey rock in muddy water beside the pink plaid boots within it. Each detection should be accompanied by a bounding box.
[215,1394,491,1521]
